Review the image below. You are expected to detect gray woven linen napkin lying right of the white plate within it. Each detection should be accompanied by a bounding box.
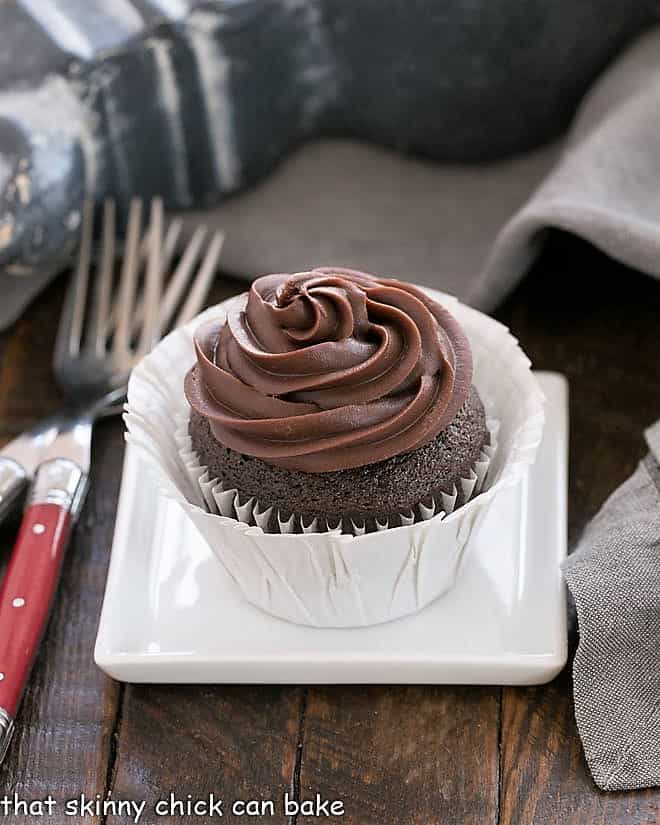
[564,421,660,791]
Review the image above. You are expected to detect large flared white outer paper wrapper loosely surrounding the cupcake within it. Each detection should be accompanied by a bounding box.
[126,290,544,627]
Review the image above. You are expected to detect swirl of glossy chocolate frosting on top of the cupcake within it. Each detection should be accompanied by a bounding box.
[185,268,472,473]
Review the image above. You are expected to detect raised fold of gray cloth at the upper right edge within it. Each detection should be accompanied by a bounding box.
[470,29,660,306]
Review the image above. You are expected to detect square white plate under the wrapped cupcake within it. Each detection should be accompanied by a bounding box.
[95,373,568,685]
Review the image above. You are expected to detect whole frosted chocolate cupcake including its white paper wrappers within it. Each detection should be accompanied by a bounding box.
[125,269,544,628]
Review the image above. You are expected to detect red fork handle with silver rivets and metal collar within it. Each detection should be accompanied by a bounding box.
[0,459,86,762]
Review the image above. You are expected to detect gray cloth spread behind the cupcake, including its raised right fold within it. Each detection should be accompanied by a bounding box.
[178,29,660,310]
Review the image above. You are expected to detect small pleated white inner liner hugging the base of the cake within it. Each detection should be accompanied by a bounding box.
[174,414,499,536]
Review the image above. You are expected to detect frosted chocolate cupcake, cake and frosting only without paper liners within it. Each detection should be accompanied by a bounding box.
[185,268,489,532]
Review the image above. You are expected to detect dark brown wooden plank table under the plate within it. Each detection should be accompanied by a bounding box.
[0,235,660,825]
